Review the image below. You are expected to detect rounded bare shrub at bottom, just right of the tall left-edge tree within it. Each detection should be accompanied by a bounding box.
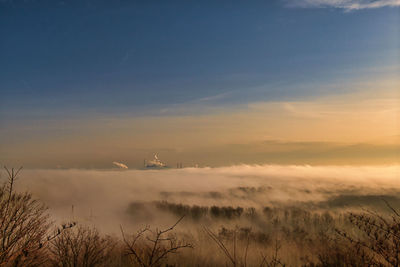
[49,226,117,267]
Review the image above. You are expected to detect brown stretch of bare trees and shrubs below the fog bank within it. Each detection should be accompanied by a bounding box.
[0,169,400,267]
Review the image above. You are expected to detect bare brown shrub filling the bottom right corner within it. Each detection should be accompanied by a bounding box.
[305,201,400,267]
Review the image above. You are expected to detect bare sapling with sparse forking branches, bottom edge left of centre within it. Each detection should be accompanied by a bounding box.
[121,216,193,267]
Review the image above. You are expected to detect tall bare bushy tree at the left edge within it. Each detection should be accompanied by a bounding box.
[0,167,50,266]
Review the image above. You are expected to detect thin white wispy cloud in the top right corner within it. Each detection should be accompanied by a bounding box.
[286,0,400,11]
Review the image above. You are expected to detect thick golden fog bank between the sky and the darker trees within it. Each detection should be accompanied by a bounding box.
[5,165,400,236]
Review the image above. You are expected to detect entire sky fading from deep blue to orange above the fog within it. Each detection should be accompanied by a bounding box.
[0,0,400,168]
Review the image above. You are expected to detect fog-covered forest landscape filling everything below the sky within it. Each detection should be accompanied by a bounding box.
[1,165,400,266]
